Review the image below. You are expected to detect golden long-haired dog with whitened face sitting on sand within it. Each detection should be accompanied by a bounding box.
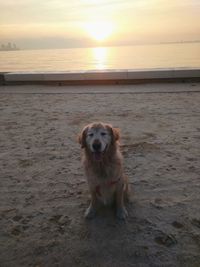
[78,122,129,220]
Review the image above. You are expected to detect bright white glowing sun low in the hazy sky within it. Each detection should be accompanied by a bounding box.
[85,22,113,42]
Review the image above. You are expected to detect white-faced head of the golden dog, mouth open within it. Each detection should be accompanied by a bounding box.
[79,122,120,161]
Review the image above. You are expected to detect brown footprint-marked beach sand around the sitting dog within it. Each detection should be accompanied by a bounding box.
[0,83,200,267]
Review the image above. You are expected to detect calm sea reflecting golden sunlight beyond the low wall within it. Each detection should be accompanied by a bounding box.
[0,42,200,72]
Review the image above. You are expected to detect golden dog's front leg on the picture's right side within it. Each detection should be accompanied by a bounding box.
[116,181,128,220]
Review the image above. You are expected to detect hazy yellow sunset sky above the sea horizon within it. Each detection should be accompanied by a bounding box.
[0,0,200,49]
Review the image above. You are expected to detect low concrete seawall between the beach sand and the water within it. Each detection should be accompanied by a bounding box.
[0,68,200,85]
